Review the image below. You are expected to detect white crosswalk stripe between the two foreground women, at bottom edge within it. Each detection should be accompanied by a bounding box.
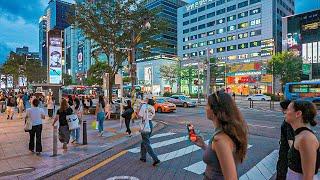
[239,150,278,180]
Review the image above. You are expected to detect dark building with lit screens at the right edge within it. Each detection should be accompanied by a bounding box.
[282,9,320,80]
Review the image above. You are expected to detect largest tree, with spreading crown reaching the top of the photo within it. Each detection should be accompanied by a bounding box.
[70,0,168,99]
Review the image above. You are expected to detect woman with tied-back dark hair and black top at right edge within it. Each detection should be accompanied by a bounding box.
[285,100,320,180]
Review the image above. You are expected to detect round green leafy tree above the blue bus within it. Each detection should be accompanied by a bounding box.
[267,52,302,90]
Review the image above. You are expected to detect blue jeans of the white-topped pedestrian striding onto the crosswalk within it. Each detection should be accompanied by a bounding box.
[140,121,159,161]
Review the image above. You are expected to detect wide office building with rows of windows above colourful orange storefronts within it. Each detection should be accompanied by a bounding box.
[177,0,294,94]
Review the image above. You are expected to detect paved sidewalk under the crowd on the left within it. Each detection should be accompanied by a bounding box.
[0,114,149,179]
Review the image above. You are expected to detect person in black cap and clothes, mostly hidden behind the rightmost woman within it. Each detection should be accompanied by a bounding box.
[276,100,294,180]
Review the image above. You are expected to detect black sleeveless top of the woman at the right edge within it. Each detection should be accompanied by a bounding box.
[288,127,320,174]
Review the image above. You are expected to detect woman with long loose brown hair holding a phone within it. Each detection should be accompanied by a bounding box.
[190,91,248,180]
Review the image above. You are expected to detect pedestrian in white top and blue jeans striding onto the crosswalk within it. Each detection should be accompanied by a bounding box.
[138,96,160,166]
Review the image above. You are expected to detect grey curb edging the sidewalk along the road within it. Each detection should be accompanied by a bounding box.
[35,120,167,179]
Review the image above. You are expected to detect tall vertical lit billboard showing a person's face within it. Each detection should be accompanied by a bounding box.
[49,37,62,84]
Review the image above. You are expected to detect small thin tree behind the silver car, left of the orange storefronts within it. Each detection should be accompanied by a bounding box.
[160,64,181,93]
